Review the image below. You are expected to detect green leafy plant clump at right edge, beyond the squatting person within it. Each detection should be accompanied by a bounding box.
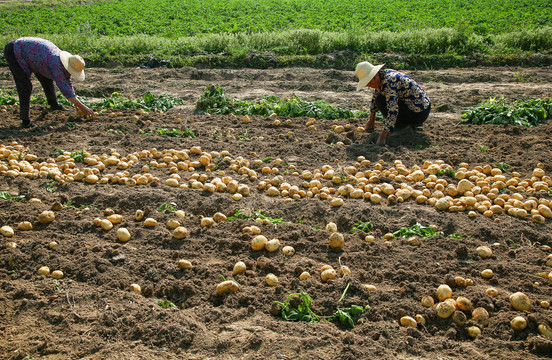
[460,98,552,127]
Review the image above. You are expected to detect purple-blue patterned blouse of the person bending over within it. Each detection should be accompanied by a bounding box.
[13,37,75,98]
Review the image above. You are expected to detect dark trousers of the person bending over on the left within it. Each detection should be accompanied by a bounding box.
[4,41,60,123]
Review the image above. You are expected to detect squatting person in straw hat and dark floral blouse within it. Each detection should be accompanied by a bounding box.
[355,61,431,146]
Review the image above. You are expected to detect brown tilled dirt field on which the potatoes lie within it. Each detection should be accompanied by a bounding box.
[0,68,552,360]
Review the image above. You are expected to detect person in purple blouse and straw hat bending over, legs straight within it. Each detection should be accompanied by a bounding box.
[4,37,94,127]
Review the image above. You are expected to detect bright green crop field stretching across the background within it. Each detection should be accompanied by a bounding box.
[0,0,552,67]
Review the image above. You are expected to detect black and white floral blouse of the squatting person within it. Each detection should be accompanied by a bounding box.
[370,69,431,132]
